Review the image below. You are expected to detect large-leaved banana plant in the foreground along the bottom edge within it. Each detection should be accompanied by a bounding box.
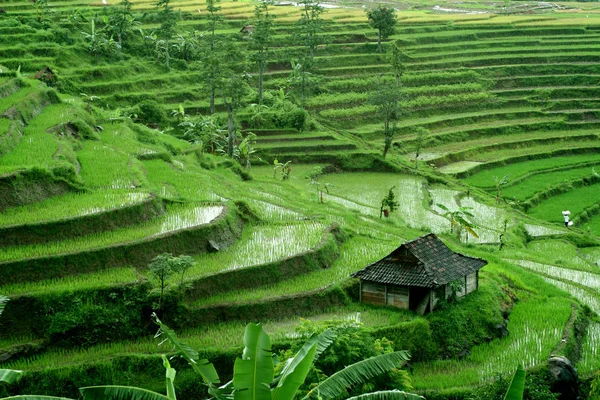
[2,315,424,400]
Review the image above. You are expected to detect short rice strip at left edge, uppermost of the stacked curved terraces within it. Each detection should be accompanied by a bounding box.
[0,190,149,227]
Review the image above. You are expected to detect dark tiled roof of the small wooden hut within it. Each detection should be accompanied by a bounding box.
[352,233,487,288]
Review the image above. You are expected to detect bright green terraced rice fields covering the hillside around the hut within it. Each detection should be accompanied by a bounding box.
[0,0,600,396]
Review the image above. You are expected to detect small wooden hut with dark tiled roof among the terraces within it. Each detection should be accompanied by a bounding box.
[352,233,487,315]
